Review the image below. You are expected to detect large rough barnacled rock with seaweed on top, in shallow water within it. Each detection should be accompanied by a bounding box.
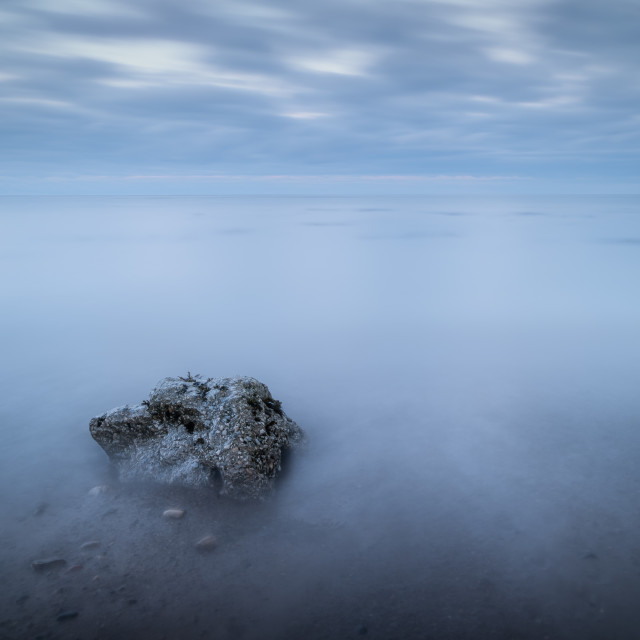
[89,374,304,499]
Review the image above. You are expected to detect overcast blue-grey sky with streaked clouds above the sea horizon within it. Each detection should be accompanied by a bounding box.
[0,0,640,193]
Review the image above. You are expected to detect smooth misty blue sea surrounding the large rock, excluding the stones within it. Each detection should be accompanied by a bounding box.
[0,196,640,639]
